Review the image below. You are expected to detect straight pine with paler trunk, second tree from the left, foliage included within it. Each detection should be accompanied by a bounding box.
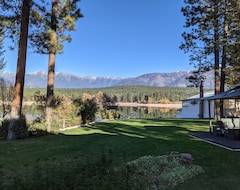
[27,0,82,131]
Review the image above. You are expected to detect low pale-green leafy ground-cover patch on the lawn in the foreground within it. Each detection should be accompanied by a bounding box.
[127,155,203,190]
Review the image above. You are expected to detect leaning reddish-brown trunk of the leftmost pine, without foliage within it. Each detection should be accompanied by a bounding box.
[7,0,31,140]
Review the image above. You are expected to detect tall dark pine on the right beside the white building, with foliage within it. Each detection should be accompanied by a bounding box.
[180,0,239,118]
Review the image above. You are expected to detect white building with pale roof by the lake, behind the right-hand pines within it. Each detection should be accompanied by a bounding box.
[176,92,214,118]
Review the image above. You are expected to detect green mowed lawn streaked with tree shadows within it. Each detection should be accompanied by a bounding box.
[0,118,240,190]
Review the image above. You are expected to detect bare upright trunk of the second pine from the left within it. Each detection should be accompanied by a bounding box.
[45,0,58,132]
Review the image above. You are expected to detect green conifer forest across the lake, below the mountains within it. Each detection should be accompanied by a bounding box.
[24,86,202,103]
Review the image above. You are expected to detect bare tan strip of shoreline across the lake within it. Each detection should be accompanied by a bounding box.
[116,102,182,109]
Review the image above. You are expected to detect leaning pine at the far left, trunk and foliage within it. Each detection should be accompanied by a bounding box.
[0,0,53,139]
